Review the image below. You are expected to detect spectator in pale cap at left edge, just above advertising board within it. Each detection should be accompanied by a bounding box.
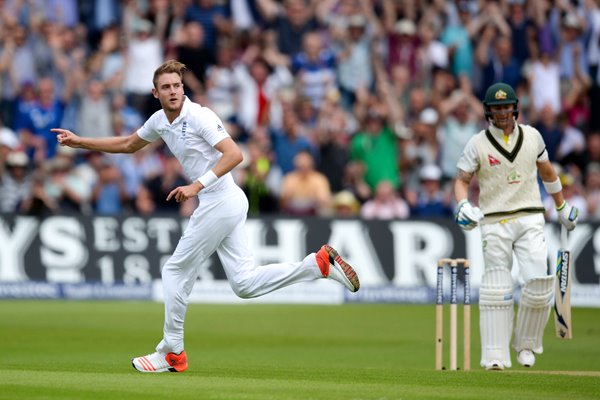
[0,151,31,213]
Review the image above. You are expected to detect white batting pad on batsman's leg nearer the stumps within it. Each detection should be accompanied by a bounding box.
[479,268,514,368]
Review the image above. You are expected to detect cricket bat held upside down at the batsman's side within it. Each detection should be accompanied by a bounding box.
[554,226,573,339]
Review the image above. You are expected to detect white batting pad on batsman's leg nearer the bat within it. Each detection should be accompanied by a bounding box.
[513,275,554,353]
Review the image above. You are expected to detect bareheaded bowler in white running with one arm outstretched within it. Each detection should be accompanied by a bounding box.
[53,60,360,372]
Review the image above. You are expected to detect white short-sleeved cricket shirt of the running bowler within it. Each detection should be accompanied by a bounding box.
[137,97,236,194]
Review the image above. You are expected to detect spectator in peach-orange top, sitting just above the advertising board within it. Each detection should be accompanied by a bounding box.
[280,151,332,216]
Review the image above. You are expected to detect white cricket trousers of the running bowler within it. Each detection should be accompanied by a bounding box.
[156,186,322,353]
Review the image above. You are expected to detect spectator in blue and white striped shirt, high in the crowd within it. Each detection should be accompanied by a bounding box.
[291,32,337,108]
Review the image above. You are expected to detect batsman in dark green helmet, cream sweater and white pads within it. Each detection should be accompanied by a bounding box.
[454,83,578,370]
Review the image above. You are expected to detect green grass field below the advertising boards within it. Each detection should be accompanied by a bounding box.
[0,300,600,400]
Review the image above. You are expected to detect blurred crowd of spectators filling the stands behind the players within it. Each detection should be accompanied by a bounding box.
[0,0,600,221]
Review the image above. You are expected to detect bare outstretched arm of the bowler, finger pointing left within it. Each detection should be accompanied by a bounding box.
[51,128,150,153]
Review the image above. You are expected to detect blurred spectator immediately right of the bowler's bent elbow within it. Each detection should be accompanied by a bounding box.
[237,139,282,216]
